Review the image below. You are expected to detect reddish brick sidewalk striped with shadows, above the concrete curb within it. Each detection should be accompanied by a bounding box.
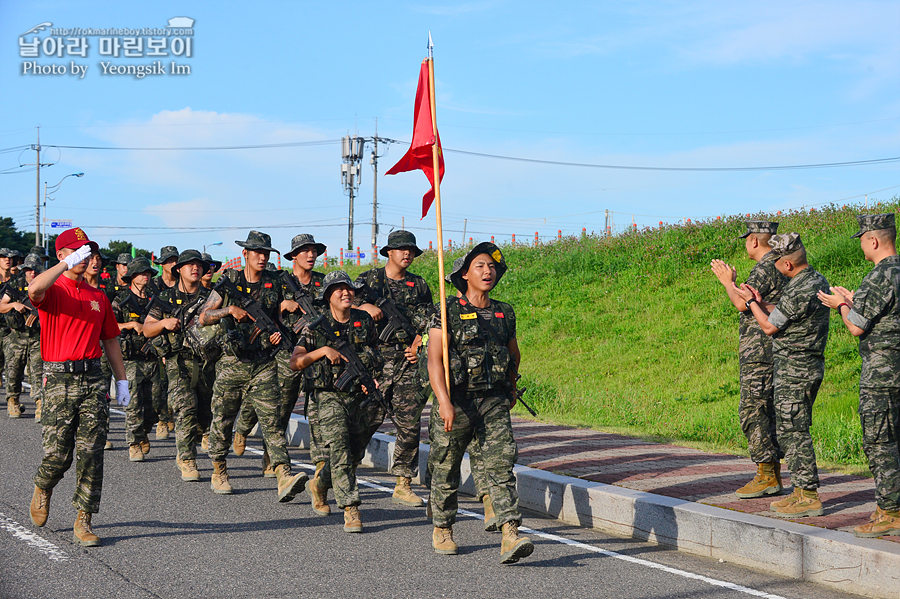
[370,405,900,542]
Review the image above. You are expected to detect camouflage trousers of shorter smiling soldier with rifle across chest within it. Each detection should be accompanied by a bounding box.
[316,391,368,509]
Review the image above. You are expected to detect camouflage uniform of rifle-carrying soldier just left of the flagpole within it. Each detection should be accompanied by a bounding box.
[354,268,434,478]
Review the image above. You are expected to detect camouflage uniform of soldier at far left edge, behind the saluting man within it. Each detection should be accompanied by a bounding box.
[3,273,44,410]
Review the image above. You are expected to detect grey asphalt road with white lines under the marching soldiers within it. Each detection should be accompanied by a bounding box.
[0,397,864,599]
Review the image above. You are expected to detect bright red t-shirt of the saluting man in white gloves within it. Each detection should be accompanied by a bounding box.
[35,275,119,362]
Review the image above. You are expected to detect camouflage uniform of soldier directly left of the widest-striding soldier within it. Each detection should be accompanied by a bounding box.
[149,278,215,461]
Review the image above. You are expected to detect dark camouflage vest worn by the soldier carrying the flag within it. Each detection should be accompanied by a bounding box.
[447,296,513,391]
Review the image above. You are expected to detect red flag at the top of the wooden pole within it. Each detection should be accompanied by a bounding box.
[385,59,444,218]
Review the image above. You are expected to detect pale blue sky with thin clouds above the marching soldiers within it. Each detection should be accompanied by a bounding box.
[0,0,900,258]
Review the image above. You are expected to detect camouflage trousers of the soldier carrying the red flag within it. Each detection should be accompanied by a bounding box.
[428,394,522,528]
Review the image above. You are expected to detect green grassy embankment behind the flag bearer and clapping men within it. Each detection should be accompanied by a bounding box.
[334,198,900,472]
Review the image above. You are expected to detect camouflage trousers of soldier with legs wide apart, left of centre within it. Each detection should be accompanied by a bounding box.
[209,356,290,468]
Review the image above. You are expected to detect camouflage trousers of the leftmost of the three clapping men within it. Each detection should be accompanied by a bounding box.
[738,364,784,464]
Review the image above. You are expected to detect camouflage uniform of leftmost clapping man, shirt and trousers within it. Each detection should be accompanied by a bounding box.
[738,252,786,464]
